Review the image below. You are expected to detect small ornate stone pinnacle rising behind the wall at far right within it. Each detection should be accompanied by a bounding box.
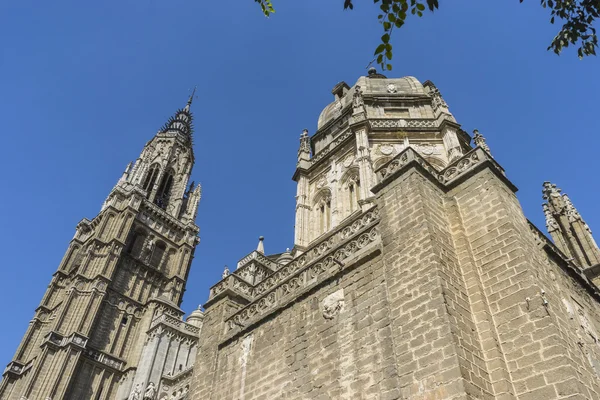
[542,182,600,268]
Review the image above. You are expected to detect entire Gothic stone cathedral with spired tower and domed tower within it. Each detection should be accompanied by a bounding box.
[0,68,600,400]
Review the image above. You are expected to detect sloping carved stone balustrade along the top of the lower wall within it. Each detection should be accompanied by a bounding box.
[220,208,380,341]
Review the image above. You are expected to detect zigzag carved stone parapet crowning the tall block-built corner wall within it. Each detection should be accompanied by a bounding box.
[373,147,508,192]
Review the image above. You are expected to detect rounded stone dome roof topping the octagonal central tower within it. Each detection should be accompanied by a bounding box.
[317,74,426,129]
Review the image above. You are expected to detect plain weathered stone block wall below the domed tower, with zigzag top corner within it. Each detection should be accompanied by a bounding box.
[191,149,600,400]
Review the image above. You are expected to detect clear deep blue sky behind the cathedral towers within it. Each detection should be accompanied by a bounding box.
[0,0,600,364]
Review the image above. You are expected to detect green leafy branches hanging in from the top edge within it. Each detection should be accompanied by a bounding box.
[254,0,600,70]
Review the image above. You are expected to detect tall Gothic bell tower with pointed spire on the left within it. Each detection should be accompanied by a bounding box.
[0,94,201,400]
